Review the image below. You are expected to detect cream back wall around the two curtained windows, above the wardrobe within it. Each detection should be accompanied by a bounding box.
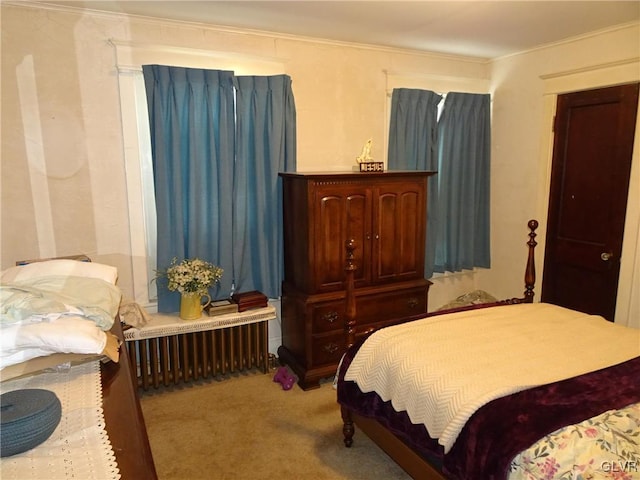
[1,2,488,292]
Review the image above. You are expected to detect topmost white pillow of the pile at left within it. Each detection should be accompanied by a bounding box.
[0,259,118,285]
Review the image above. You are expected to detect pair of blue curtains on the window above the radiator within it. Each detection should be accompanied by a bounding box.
[143,65,295,312]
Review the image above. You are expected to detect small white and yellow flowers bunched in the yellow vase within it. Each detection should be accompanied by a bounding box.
[156,257,223,295]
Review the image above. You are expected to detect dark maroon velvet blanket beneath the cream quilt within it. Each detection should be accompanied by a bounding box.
[338,339,640,480]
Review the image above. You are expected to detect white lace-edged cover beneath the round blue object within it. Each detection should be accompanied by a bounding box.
[0,361,120,480]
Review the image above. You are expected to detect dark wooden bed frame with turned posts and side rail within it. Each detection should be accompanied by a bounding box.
[340,220,538,480]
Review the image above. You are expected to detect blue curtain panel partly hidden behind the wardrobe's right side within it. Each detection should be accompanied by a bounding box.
[387,88,442,278]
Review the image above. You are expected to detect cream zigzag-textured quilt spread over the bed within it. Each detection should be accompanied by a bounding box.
[345,303,640,452]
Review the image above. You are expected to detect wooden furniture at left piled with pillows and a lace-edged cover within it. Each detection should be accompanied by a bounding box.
[0,258,157,480]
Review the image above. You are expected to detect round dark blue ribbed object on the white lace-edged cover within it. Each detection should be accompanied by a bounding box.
[0,388,62,457]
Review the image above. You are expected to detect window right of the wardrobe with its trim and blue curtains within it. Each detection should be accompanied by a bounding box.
[386,70,490,278]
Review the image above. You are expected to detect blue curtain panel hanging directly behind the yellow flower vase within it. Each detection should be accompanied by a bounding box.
[143,65,235,312]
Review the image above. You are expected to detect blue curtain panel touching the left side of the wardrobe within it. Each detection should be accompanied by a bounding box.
[233,75,296,298]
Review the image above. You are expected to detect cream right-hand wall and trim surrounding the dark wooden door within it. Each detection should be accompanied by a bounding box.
[478,24,640,327]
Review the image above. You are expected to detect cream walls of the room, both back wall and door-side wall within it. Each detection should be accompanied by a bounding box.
[1,2,640,326]
